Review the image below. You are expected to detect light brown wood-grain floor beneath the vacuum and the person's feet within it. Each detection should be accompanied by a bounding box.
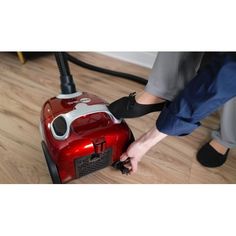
[0,52,236,183]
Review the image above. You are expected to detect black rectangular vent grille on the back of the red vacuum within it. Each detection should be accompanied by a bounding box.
[75,148,112,178]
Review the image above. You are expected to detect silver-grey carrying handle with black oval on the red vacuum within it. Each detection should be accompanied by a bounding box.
[50,103,121,140]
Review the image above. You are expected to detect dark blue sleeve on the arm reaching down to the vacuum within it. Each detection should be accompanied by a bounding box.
[156,53,236,136]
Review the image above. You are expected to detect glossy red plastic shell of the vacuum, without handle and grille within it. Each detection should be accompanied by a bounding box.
[40,93,133,183]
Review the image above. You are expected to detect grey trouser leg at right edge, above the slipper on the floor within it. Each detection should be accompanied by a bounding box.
[212,98,236,148]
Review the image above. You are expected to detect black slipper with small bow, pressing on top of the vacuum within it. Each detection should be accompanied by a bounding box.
[108,92,166,119]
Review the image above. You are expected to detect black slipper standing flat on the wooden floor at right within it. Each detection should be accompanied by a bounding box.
[197,143,230,167]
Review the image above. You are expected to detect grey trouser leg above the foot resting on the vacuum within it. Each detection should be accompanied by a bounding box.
[145,52,203,101]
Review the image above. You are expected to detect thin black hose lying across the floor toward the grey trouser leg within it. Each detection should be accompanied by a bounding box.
[65,53,147,85]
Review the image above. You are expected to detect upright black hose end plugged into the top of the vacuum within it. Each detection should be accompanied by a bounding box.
[55,52,76,94]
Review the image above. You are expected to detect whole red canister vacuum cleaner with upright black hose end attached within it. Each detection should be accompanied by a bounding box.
[40,52,134,184]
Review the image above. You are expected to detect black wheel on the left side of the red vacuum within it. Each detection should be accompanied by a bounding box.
[42,141,61,184]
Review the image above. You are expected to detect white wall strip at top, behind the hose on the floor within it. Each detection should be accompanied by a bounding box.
[100,52,157,68]
